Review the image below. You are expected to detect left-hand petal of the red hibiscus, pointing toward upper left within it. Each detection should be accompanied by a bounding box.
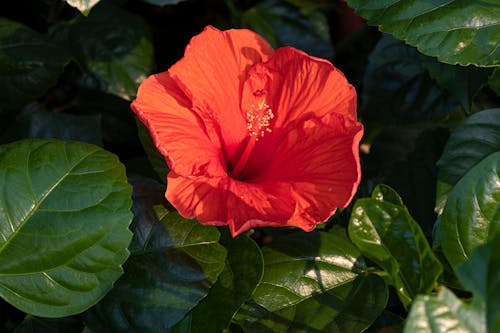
[131,72,226,176]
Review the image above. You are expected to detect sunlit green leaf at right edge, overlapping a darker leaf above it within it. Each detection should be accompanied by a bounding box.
[439,151,500,267]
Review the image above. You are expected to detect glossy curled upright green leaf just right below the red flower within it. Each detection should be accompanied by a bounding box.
[348,185,443,306]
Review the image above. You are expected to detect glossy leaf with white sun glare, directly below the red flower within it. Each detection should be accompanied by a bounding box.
[253,232,365,311]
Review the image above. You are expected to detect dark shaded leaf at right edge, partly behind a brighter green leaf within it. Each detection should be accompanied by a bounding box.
[436,109,500,214]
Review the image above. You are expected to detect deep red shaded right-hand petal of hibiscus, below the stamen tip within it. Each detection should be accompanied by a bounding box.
[252,113,363,231]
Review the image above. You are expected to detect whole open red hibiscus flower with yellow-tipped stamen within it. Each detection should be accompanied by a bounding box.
[132,27,363,236]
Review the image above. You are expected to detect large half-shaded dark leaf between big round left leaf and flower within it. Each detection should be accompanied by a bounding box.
[86,176,226,332]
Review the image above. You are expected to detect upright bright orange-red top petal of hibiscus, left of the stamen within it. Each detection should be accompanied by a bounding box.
[169,26,274,160]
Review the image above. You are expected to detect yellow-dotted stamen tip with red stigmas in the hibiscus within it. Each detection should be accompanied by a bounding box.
[245,89,274,141]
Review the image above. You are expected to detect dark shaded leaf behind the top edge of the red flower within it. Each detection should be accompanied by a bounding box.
[241,0,334,59]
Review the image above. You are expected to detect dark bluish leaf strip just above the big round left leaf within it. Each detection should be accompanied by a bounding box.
[2,111,102,146]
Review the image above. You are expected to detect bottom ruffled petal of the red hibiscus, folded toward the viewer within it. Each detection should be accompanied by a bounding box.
[166,172,295,237]
